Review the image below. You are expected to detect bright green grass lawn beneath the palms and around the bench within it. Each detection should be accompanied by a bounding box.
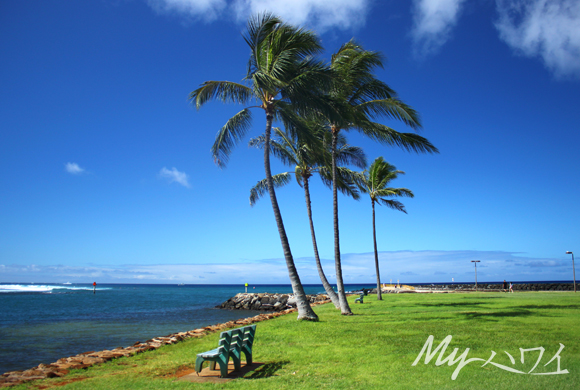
[14,292,580,390]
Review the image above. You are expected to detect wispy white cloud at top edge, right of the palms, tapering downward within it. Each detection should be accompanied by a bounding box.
[411,0,465,57]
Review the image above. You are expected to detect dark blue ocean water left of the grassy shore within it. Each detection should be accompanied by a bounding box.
[0,284,373,374]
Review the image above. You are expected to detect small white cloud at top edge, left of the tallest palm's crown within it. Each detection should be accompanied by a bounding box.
[147,0,227,22]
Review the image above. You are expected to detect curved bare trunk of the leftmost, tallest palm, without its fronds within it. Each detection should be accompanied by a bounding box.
[264,112,318,321]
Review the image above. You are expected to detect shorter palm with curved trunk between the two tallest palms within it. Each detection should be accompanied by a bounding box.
[250,122,366,309]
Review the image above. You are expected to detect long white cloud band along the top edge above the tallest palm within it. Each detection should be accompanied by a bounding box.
[147,0,370,33]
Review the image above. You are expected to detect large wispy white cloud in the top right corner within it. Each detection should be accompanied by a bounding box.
[495,0,580,77]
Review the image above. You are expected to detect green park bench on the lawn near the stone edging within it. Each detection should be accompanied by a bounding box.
[195,325,256,378]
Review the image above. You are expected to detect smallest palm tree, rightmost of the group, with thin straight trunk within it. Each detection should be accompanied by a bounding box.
[357,157,415,301]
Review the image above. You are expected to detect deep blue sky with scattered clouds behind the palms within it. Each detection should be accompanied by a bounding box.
[0,0,580,284]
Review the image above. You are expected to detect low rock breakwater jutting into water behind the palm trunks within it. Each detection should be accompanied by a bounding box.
[216,293,330,312]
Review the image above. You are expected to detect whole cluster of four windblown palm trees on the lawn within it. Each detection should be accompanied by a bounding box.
[189,13,437,321]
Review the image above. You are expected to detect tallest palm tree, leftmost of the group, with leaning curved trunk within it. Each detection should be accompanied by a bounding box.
[189,13,329,321]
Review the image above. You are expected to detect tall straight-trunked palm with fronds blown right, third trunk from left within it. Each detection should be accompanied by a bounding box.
[329,41,438,315]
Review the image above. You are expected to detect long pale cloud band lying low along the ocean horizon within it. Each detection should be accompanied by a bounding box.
[0,251,572,284]
